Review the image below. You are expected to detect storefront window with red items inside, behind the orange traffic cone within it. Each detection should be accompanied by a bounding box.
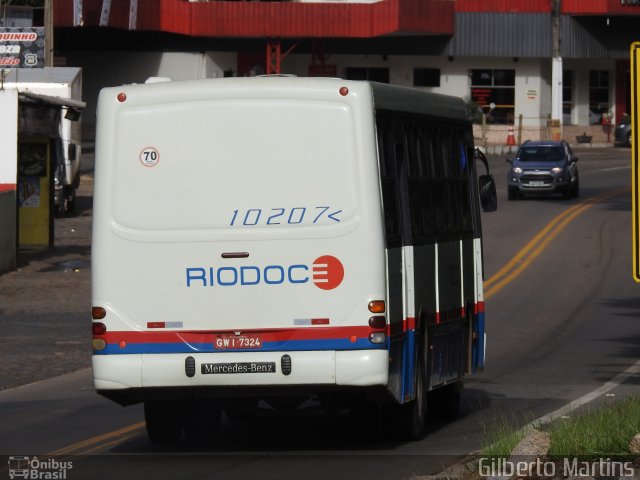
[471,69,516,124]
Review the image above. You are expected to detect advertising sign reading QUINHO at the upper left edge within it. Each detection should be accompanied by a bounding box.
[0,27,44,69]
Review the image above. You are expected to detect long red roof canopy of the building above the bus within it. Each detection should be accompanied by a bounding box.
[54,0,454,38]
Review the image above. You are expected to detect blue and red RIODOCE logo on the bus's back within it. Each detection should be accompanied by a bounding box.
[185,255,344,290]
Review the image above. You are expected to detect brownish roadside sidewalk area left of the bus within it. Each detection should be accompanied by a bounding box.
[0,174,93,390]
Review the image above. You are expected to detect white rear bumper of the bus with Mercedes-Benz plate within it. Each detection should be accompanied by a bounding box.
[93,349,389,402]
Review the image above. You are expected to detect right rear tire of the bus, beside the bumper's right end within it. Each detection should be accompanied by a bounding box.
[398,335,427,441]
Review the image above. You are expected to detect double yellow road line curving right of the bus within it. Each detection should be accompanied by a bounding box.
[484,187,629,300]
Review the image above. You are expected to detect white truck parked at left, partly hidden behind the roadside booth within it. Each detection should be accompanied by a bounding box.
[4,67,82,215]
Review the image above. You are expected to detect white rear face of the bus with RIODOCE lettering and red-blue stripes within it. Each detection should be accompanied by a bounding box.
[92,77,389,424]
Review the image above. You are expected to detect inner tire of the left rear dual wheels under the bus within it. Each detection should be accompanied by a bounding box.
[184,398,221,444]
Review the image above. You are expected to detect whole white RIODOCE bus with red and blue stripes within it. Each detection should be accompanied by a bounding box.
[92,76,495,442]
